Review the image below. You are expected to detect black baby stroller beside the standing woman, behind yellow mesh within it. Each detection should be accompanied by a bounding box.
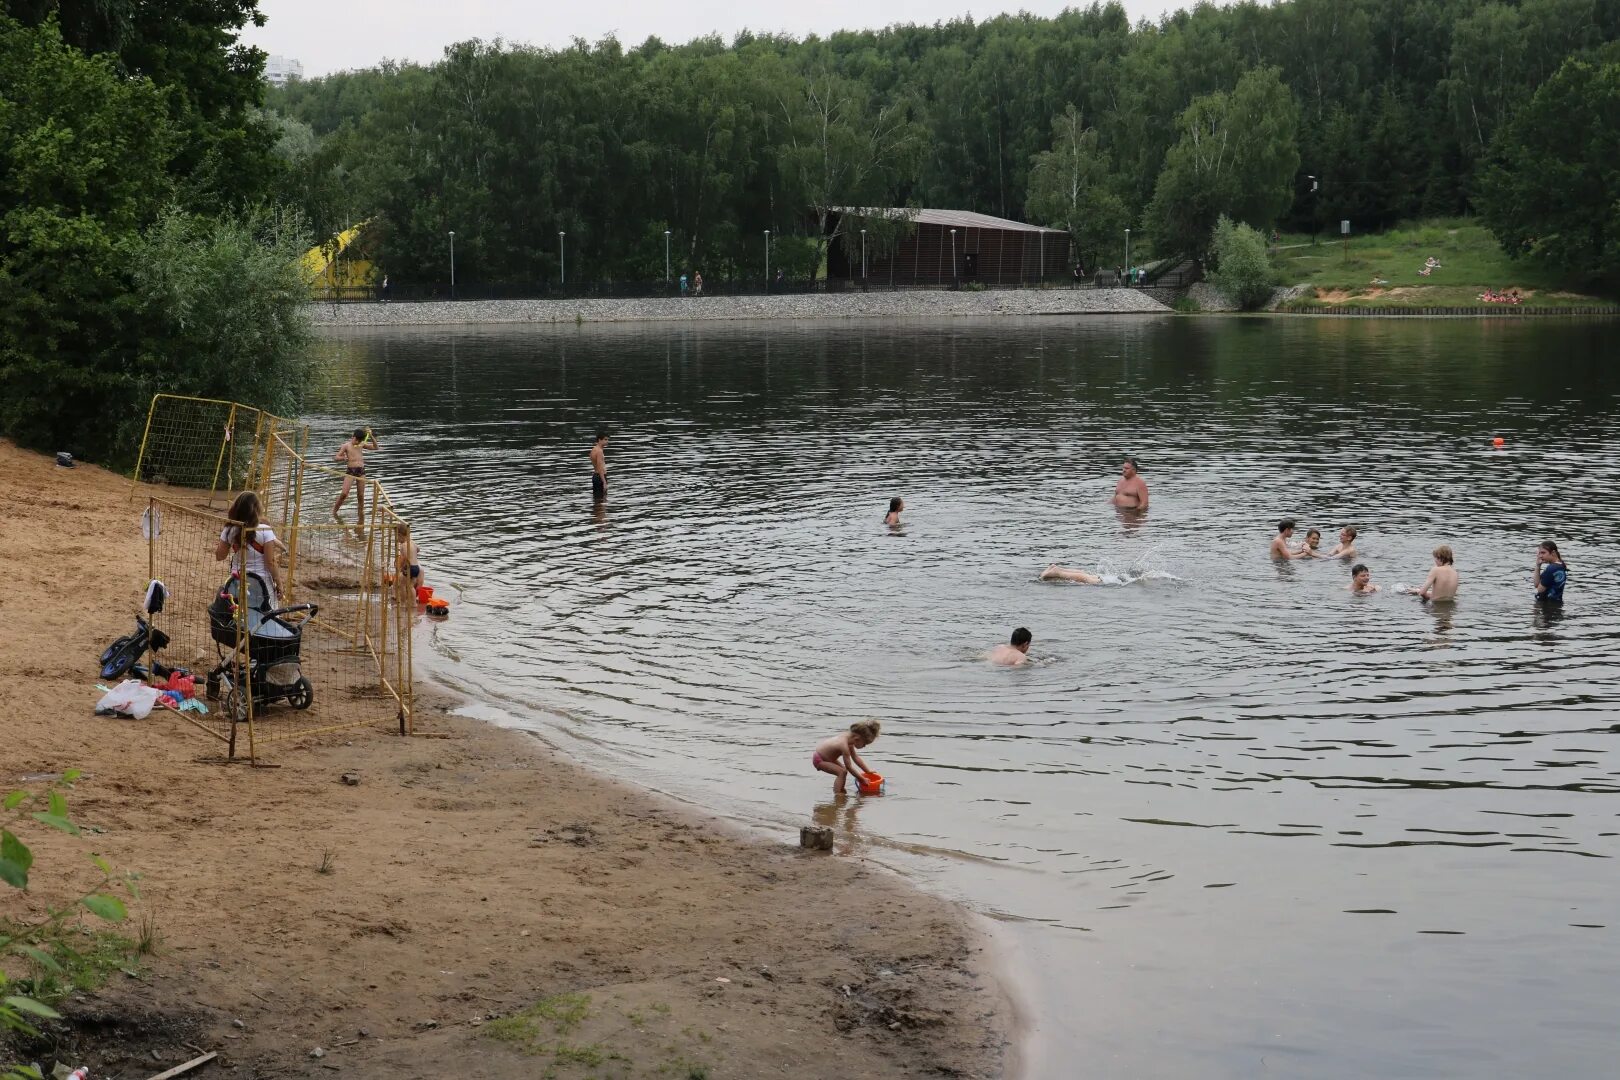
[207,573,319,721]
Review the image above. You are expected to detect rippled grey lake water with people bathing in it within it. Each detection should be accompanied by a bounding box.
[311,317,1620,1078]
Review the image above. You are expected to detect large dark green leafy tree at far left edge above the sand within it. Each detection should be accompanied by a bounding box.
[0,16,175,457]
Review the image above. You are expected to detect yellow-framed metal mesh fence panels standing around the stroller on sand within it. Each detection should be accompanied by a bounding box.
[136,395,416,759]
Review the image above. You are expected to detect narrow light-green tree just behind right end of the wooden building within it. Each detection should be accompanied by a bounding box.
[1029,105,1131,275]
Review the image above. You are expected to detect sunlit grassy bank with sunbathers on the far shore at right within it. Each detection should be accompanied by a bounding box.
[1272,219,1614,311]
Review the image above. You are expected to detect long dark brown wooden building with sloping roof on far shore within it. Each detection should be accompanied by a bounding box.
[826,207,1072,288]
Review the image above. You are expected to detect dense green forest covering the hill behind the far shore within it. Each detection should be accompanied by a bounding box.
[267,0,1620,282]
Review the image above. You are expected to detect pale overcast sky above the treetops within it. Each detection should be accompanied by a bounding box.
[243,0,1192,78]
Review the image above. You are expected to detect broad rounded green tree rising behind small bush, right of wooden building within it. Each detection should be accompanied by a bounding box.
[1147,68,1299,254]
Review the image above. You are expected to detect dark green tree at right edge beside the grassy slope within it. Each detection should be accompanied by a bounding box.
[1479,49,1620,287]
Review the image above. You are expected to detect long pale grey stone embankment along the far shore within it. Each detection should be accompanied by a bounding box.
[309,288,1170,327]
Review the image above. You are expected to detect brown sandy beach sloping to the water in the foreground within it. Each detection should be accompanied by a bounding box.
[0,444,1013,1080]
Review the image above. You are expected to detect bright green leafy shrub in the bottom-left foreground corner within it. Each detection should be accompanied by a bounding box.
[0,769,139,1080]
